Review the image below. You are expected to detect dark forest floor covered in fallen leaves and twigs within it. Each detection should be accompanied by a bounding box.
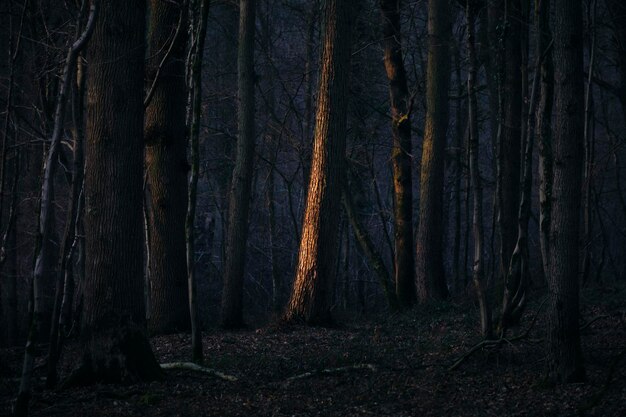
[0,287,626,417]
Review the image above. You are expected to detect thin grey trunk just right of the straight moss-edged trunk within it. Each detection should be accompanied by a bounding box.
[465,0,492,339]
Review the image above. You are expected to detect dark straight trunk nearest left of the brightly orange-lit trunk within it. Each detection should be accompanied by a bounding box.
[221,0,256,328]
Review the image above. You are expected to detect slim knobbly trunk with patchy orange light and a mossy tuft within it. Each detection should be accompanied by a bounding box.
[380,0,416,308]
